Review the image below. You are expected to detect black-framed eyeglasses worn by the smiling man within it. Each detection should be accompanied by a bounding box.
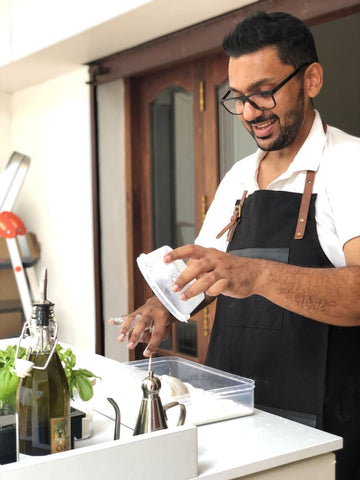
[220,63,311,115]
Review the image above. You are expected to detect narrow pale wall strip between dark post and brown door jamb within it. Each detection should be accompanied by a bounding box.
[97,79,129,361]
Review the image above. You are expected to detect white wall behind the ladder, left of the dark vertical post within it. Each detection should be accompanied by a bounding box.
[7,67,95,350]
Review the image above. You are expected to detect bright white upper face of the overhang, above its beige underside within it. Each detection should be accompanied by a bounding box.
[0,0,151,65]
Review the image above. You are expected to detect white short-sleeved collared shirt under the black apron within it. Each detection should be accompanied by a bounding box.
[195,112,360,267]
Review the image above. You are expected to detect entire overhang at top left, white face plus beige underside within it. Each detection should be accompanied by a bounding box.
[0,0,254,92]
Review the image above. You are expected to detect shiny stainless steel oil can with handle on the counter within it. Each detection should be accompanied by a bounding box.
[134,370,186,435]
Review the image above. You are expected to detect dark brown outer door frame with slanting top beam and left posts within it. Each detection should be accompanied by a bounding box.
[88,0,360,354]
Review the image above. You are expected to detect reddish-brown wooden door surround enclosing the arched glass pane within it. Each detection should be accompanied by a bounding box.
[129,51,228,362]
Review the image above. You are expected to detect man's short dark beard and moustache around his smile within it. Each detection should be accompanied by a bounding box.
[247,88,305,152]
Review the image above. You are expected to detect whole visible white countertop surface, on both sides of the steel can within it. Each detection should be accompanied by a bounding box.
[0,341,342,480]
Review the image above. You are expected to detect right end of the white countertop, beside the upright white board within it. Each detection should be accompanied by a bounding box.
[194,410,342,480]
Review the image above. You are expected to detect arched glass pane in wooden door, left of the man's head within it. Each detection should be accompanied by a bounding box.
[150,86,195,248]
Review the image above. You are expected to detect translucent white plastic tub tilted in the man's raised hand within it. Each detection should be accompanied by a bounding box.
[136,245,205,322]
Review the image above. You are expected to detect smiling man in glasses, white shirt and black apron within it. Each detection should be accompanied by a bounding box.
[119,13,360,480]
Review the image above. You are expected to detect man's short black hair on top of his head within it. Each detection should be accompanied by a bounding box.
[222,12,318,68]
